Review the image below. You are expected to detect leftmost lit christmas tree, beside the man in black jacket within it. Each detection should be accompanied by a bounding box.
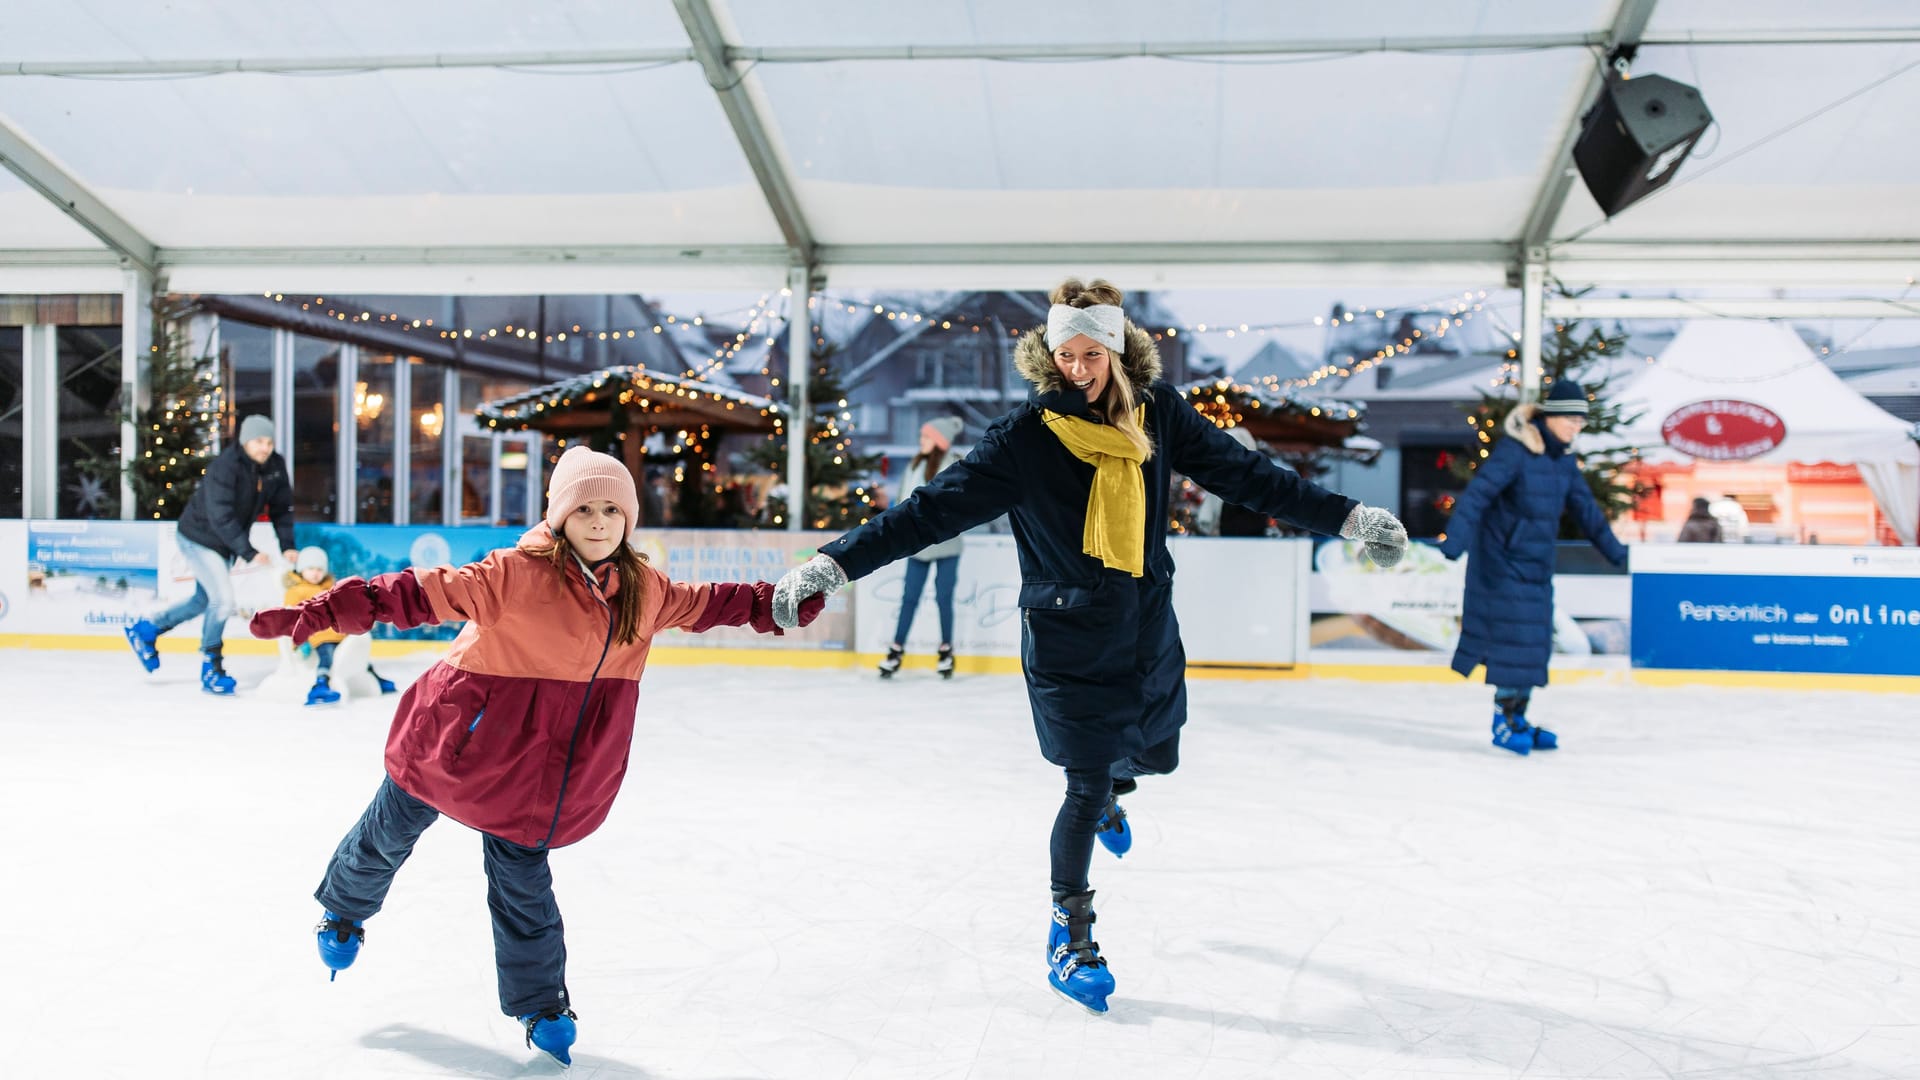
[81,298,219,521]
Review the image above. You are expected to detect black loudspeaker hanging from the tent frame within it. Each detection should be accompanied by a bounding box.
[1572,75,1713,217]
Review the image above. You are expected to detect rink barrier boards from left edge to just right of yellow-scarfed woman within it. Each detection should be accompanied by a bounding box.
[0,521,1311,665]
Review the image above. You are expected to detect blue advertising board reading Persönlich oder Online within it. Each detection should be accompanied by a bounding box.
[1632,544,1920,675]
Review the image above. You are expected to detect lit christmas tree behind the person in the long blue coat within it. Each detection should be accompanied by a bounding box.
[1452,282,1647,540]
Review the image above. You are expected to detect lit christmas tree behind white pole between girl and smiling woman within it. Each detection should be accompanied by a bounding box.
[749,346,881,528]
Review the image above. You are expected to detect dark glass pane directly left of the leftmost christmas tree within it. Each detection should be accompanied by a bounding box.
[54,327,121,517]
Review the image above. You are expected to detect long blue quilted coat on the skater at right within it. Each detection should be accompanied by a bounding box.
[1440,405,1626,688]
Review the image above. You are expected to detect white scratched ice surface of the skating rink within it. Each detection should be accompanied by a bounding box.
[0,651,1920,1080]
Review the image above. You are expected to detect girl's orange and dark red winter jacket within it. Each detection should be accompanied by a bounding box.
[253,523,820,847]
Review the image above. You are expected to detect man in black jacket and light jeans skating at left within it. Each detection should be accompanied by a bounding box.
[127,415,298,694]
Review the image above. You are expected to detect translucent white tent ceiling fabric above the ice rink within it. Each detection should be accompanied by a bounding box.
[0,0,1920,292]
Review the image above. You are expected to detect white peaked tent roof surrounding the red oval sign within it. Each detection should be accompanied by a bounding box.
[1619,319,1920,544]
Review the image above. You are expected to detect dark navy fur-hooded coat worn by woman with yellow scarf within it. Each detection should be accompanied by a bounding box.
[822,323,1354,769]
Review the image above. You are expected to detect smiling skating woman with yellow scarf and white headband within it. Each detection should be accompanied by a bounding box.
[774,281,1407,1013]
